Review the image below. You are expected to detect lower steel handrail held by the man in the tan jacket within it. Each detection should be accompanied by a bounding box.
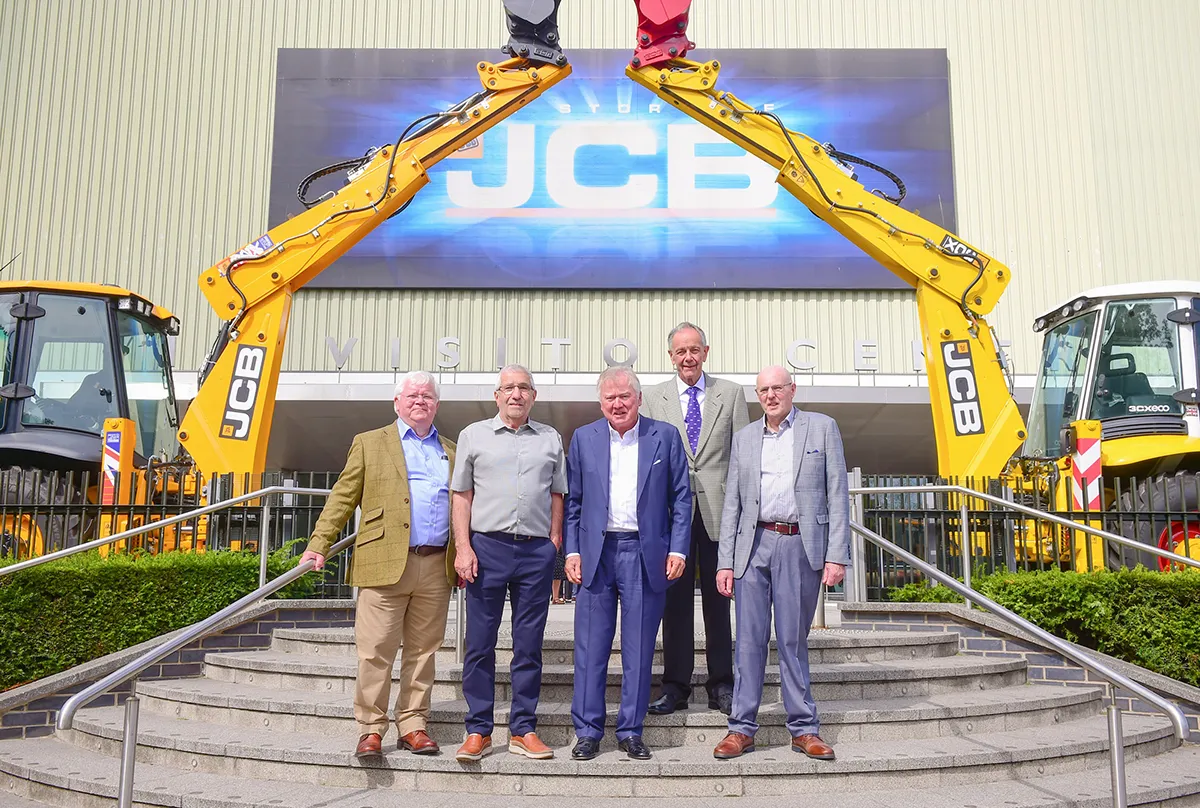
[55,525,358,808]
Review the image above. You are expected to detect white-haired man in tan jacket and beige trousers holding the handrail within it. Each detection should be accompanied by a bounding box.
[301,371,456,759]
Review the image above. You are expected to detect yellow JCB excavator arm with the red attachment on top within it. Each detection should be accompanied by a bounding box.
[625,0,1025,477]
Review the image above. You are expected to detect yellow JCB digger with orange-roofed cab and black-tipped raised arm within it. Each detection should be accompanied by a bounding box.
[0,0,571,556]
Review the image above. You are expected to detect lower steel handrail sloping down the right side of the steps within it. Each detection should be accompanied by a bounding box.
[850,516,1190,808]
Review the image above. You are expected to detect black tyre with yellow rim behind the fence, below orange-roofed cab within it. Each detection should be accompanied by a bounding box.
[0,466,95,558]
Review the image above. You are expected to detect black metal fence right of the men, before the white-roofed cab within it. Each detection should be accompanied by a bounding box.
[860,474,1200,600]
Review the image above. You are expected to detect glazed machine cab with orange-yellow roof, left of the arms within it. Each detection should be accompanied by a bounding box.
[0,282,179,471]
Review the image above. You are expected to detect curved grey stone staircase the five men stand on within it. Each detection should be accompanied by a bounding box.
[0,608,1200,808]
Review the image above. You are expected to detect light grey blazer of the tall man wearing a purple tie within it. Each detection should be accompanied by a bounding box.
[641,373,750,541]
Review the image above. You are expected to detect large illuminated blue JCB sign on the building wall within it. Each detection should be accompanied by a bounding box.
[270,49,955,289]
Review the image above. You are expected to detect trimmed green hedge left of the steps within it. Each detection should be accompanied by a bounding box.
[0,545,317,690]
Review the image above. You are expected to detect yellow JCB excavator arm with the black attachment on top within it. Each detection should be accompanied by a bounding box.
[179,0,571,474]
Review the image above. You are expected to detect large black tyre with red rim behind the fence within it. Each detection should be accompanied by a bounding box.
[1108,472,1200,570]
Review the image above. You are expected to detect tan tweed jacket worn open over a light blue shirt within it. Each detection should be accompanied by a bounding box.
[308,423,457,586]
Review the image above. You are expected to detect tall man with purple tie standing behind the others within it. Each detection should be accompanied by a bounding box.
[642,323,750,716]
